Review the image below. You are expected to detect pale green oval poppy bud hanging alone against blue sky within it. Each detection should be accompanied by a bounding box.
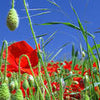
[7,8,19,31]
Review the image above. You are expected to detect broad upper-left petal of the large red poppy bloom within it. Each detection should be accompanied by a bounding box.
[3,41,33,65]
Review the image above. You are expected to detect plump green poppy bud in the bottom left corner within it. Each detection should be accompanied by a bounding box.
[0,83,10,100]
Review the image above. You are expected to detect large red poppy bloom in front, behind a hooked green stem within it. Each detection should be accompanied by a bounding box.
[3,41,38,72]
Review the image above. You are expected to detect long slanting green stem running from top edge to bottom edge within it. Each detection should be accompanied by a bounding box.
[23,0,55,100]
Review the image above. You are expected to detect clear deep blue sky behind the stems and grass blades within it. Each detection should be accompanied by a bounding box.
[0,0,100,59]
